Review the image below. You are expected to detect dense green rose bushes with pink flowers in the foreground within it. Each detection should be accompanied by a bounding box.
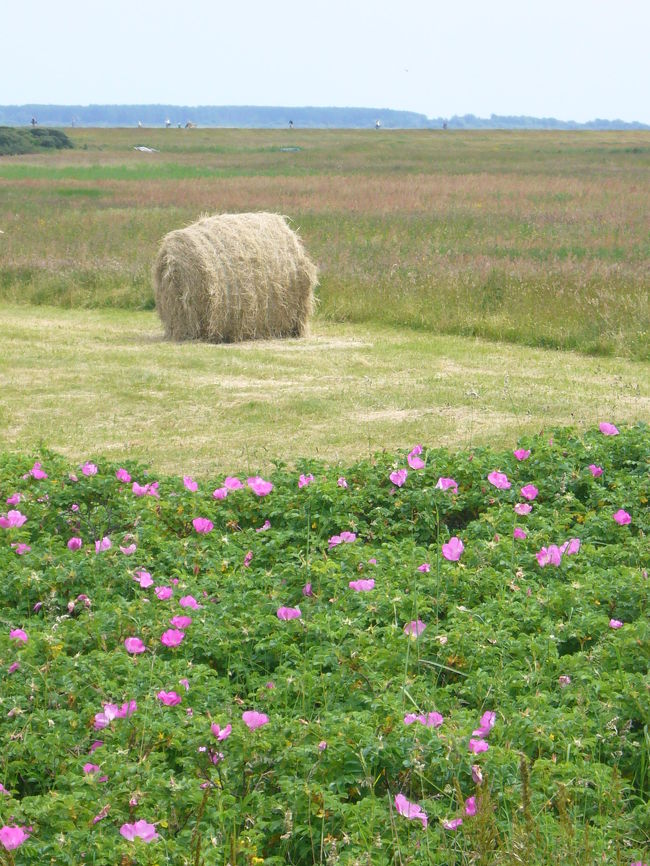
[0,425,650,866]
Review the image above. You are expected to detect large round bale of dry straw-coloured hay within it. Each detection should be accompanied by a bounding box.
[153,213,316,343]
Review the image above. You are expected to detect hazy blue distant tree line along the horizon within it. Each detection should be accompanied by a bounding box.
[0,105,650,130]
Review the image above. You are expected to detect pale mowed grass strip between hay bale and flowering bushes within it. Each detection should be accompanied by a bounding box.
[0,305,650,475]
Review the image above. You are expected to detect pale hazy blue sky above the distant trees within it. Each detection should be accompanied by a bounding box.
[0,0,650,123]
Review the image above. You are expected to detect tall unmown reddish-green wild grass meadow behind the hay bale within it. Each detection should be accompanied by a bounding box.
[0,130,650,359]
